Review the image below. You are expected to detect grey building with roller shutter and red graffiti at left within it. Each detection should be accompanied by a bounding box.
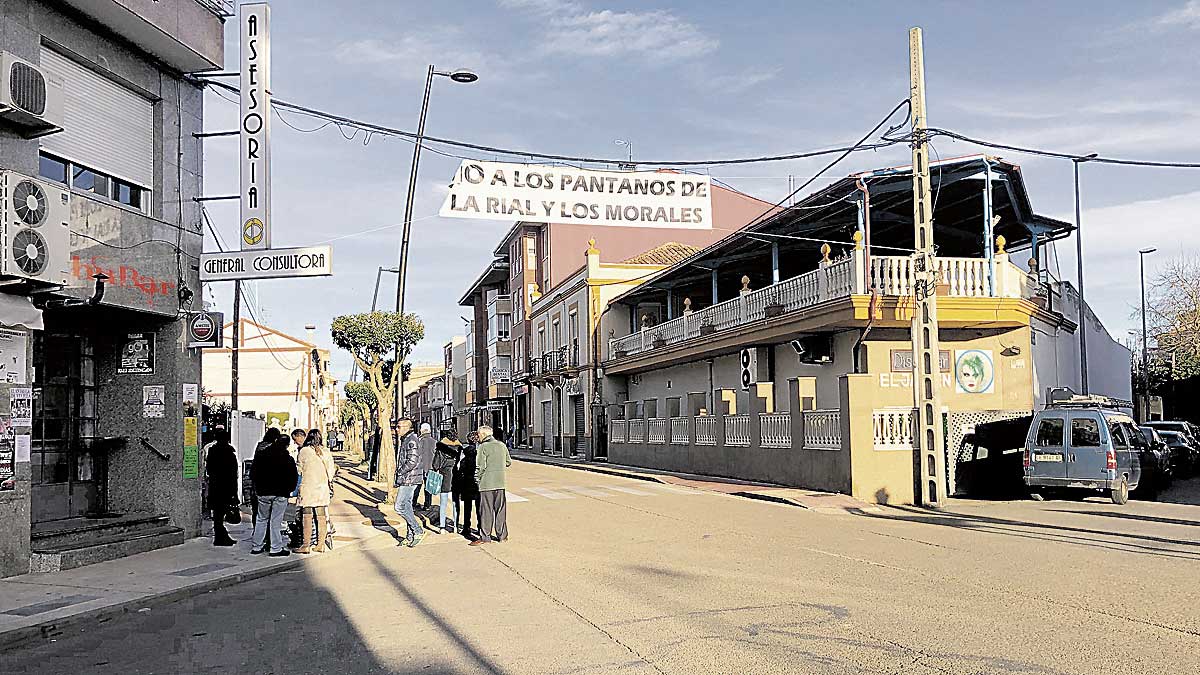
[0,0,225,575]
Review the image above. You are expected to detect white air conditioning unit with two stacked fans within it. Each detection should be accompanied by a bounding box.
[0,171,71,286]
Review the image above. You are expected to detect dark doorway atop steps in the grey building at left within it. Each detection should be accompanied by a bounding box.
[30,333,106,524]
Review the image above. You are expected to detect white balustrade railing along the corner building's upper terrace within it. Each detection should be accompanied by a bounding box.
[608,250,1034,358]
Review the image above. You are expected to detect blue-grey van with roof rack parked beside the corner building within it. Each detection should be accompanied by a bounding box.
[1022,396,1145,504]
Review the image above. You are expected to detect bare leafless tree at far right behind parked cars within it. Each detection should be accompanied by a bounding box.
[1146,256,1200,381]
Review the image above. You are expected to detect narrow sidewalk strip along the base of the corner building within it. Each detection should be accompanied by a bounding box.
[512,450,882,514]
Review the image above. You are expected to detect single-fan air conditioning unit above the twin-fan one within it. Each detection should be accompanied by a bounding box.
[0,52,62,138]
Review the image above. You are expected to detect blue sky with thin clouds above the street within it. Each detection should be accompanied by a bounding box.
[204,0,1200,380]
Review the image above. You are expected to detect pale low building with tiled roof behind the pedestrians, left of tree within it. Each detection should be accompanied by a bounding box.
[204,318,338,431]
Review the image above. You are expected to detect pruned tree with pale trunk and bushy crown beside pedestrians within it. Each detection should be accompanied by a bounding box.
[330,312,425,498]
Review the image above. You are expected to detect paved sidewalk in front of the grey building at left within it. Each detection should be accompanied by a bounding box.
[0,451,403,650]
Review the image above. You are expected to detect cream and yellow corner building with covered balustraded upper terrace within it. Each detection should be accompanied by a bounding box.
[601,156,1130,503]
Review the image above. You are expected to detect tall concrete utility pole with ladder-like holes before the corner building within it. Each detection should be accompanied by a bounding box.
[908,28,946,507]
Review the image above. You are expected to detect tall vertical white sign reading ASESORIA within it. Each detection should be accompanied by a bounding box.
[239,2,271,250]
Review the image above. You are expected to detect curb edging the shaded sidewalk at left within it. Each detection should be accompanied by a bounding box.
[0,526,381,653]
